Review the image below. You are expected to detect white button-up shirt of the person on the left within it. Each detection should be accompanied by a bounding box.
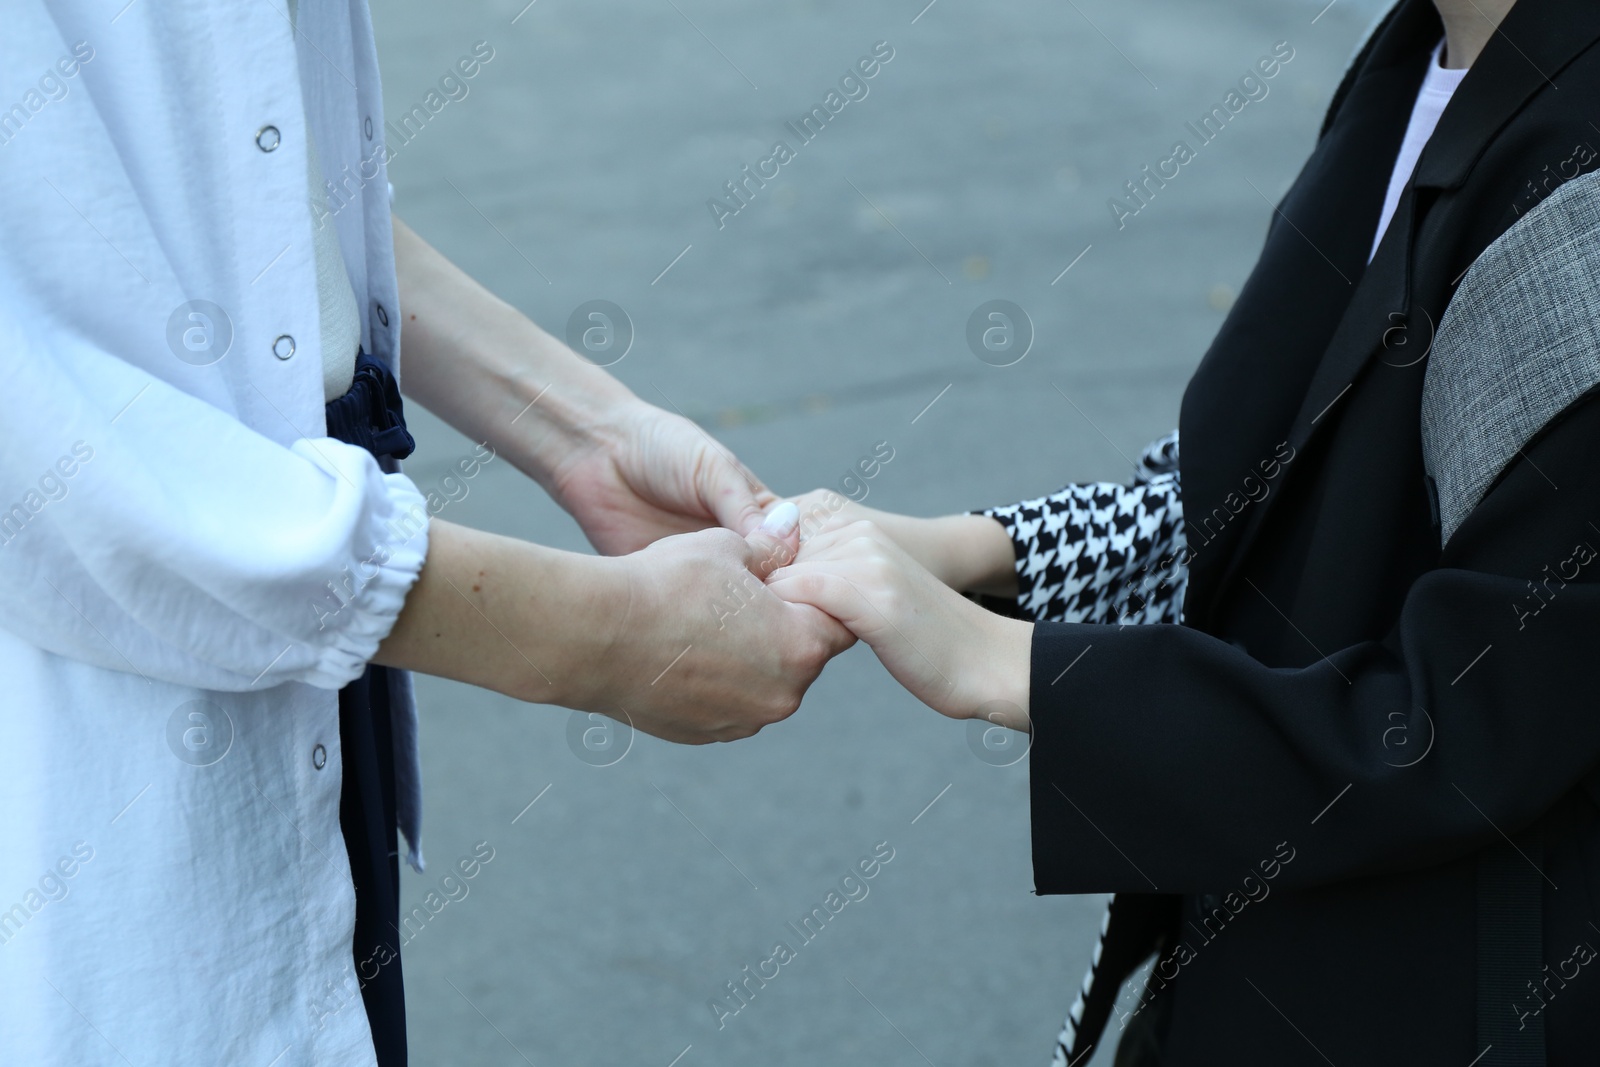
[0,0,427,1067]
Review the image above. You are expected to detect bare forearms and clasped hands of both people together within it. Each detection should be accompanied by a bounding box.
[373,219,1032,744]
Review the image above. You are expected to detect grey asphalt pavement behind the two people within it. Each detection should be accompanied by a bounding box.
[374,0,1378,1067]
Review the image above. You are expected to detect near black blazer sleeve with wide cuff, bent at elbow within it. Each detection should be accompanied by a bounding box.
[1029,395,1600,893]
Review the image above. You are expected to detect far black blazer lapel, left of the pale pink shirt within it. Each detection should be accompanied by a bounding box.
[1181,20,1440,629]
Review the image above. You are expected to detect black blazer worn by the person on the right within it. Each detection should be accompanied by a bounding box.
[1030,0,1600,1067]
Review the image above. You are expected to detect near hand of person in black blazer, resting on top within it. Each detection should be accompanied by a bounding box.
[768,522,1034,729]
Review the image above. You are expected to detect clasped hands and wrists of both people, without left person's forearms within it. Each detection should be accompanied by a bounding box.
[528,405,1032,742]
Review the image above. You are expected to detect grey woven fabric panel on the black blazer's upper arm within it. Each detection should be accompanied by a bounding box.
[1422,171,1600,542]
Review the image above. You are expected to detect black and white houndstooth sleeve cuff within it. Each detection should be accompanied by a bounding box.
[979,430,1187,624]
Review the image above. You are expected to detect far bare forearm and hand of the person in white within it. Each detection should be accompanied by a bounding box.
[394,219,776,553]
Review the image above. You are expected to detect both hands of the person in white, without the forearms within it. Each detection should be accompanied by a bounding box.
[536,397,856,744]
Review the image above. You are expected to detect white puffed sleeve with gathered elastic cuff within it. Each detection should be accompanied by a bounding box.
[0,315,427,691]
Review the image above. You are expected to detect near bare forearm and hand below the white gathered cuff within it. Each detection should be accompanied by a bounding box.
[374,506,856,744]
